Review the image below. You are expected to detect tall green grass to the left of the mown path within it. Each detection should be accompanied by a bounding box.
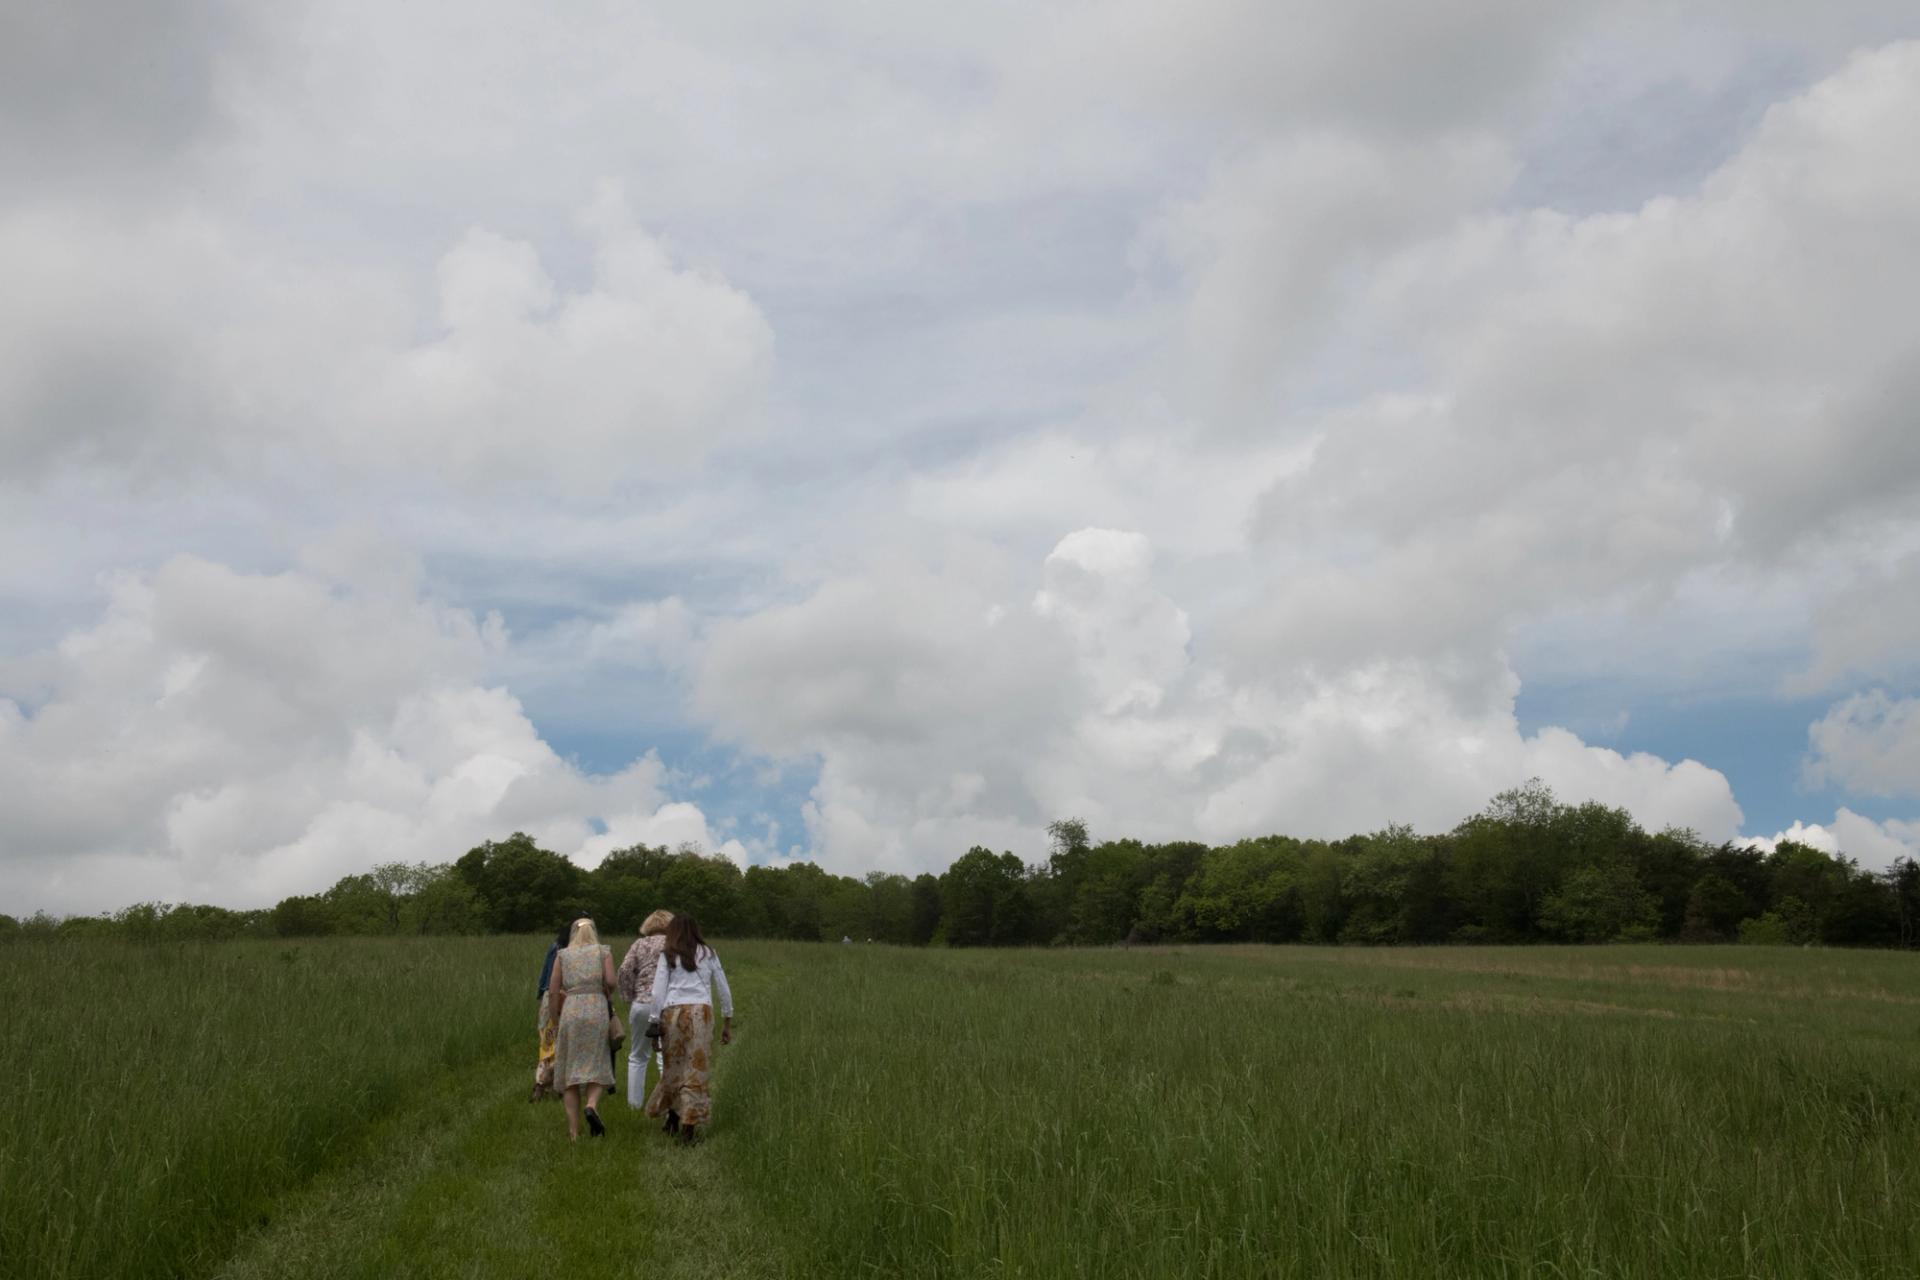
[0,938,543,1280]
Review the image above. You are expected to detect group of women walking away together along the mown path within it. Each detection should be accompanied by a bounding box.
[534,912,733,1144]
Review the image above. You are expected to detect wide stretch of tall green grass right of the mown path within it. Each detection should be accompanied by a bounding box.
[716,946,1920,1276]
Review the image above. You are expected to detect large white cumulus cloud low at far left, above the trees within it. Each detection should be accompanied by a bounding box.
[0,557,725,910]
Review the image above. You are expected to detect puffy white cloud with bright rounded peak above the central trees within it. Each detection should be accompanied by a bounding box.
[697,530,1741,869]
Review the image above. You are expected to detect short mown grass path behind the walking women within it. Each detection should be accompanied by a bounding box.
[215,979,789,1280]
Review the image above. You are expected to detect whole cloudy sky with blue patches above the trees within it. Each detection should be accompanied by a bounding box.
[0,0,1920,913]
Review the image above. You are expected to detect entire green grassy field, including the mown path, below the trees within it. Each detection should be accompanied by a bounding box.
[0,938,1920,1278]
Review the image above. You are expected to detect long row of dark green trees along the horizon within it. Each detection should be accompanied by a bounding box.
[0,779,1920,948]
